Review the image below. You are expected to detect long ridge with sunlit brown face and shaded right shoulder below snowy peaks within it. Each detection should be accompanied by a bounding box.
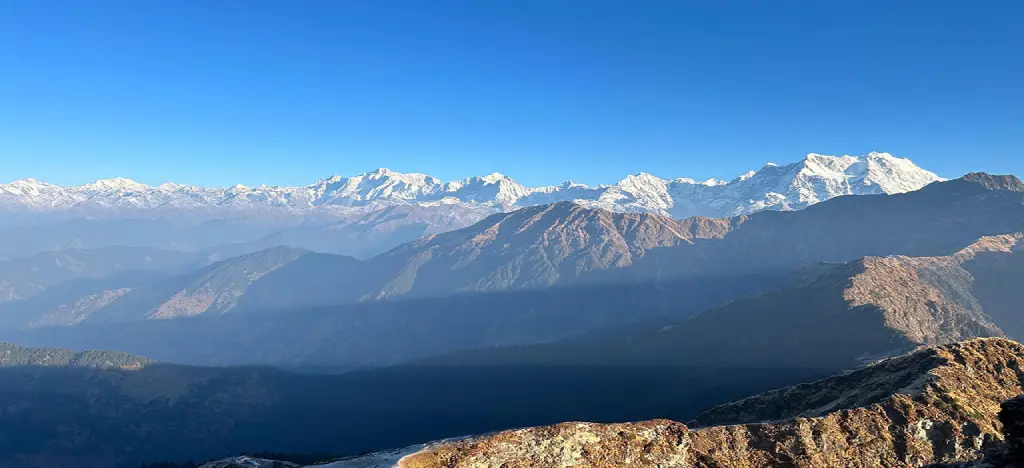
[251,174,1024,299]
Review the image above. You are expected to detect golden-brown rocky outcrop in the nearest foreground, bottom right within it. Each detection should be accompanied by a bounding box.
[398,338,1024,468]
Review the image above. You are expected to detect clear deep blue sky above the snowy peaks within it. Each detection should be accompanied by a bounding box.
[0,0,1024,185]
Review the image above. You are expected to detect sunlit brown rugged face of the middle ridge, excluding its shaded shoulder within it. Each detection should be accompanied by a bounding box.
[350,202,733,297]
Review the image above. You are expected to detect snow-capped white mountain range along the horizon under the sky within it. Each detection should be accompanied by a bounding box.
[0,153,941,218]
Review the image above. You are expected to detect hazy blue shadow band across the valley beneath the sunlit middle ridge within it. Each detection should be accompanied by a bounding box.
[2,272,790,372]
